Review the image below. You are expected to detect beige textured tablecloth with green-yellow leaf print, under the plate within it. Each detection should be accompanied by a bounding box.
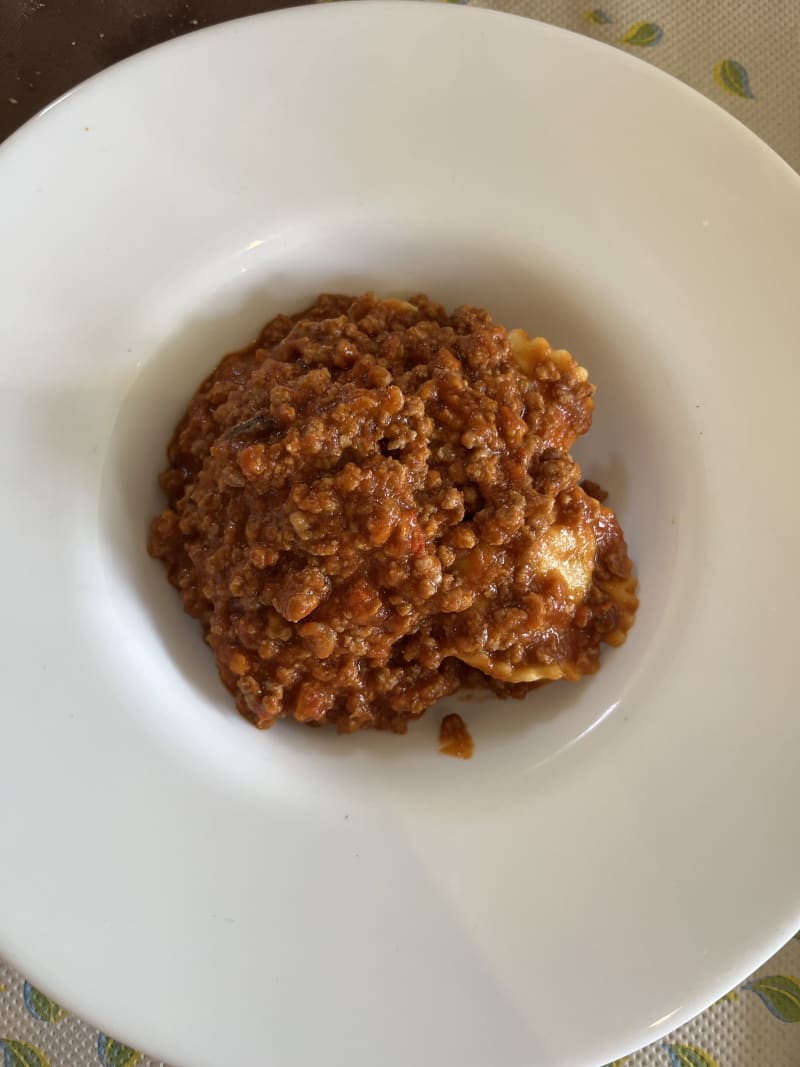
[0,0,800,1067]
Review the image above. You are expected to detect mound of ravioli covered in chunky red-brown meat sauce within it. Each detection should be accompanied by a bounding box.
[148,293,636,732]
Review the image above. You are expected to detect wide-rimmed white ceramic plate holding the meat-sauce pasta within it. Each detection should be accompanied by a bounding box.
[0,3,800,1067]
